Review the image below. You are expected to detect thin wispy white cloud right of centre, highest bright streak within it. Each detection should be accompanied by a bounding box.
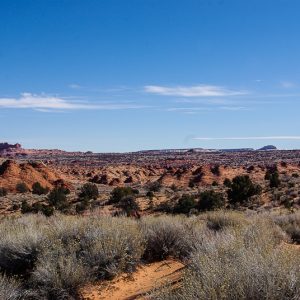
[144,85,246,97]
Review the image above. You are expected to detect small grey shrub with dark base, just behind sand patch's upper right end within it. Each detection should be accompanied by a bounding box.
[141,216,191,261]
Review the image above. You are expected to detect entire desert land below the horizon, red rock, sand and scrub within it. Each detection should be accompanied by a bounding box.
[0,143,300,300]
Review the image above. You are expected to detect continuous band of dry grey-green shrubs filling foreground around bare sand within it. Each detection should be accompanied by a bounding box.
[0,211,300,300]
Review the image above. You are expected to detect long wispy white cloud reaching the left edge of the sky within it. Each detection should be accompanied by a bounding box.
[0,93,145,112]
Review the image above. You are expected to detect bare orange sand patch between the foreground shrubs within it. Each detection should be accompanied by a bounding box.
[81,260,184,300]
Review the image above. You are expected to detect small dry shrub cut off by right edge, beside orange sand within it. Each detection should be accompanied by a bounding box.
[273,211,300,244]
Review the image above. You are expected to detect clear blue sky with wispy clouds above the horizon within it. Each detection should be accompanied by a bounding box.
[0,0,300,152]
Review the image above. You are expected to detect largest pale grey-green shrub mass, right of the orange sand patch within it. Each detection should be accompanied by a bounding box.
[154,217,300,300]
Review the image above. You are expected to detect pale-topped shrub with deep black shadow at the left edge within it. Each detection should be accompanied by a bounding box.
[0,216,44,275]
